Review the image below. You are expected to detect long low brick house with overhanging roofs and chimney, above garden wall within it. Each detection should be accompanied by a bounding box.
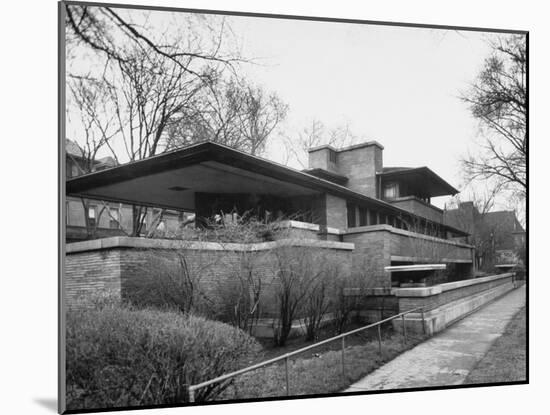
[67,141,474,294]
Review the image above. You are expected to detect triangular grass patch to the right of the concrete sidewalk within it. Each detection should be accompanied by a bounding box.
[464,307,527,384]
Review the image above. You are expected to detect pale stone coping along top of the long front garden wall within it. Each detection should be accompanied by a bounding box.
[65,236,355,254]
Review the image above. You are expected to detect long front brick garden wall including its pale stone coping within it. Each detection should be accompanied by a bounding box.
[64,238,353,318]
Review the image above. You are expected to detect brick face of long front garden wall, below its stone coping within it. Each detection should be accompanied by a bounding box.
[64,239,352,318]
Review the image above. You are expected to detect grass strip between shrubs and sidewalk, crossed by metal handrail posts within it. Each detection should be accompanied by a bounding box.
[217,325,423,399]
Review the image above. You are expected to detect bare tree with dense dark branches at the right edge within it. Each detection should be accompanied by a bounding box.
[462,35,527,198]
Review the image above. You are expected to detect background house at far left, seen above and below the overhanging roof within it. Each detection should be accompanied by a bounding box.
[65,139,188,242]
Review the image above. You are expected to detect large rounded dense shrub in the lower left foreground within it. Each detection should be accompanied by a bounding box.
[66,306,260,410]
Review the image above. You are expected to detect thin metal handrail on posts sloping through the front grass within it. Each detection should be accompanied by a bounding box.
[187,307,426,402]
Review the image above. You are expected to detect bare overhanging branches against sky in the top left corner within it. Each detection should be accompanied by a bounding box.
[66,5,243,82]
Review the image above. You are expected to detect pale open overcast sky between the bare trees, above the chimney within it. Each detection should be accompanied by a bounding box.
[222,17,502,207]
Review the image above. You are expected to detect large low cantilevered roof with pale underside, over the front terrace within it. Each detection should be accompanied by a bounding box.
[66,141,467,235]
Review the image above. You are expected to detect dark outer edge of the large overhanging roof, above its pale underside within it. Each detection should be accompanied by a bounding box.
[66,141,468,235]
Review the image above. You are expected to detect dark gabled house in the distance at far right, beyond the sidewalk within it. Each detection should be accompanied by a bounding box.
[444,201,525,270]
